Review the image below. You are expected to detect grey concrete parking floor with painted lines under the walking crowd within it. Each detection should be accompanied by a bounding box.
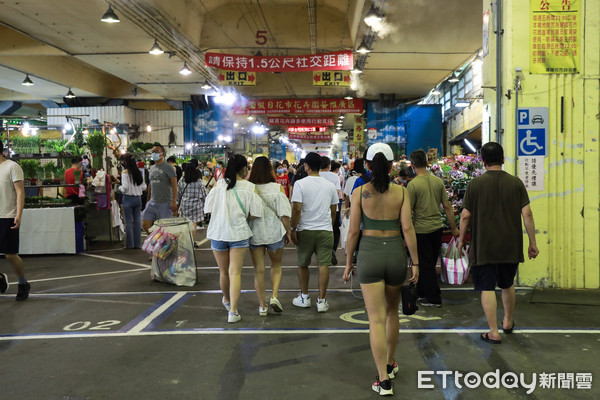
[0,231,600,400]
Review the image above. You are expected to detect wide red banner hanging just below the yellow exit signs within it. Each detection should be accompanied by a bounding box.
[234,99,363,115]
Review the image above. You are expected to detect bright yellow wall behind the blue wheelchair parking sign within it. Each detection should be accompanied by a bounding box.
[482,0,600,288]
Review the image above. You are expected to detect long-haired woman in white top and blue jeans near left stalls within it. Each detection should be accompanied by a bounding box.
[120,154,146,249]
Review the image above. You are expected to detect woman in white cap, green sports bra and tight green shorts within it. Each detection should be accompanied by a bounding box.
[344,143,419,395]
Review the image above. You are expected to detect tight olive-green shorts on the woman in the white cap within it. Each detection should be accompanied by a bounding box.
[356,235,407,286]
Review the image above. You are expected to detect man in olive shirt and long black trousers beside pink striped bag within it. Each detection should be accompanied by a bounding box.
[407,150,459,307]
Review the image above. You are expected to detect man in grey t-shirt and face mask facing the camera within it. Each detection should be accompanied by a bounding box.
[142,143,177,232]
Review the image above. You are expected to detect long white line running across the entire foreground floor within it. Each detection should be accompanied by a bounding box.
[0,328,600,342]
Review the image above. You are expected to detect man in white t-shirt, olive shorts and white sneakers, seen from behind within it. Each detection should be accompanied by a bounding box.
[291,152,339,312]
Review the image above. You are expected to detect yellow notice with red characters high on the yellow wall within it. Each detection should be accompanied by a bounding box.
[529,0,583,74]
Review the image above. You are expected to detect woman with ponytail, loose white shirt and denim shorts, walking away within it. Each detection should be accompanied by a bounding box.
[204,154,263,322]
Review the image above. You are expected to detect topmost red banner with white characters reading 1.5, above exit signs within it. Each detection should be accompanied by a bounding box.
[204,50,354,72]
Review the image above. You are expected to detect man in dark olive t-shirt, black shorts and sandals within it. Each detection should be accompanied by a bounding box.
[458,142,539,344]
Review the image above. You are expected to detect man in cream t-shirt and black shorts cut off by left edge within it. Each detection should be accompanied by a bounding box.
[0,140,31,301]
